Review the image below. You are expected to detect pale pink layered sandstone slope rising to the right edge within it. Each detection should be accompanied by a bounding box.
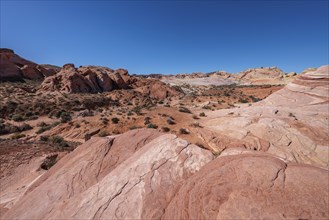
[195,66,329,168]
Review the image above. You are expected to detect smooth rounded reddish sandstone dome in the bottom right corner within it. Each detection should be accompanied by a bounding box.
[162,153,329,219]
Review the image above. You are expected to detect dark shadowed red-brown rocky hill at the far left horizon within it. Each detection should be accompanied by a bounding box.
[0,48,54,81]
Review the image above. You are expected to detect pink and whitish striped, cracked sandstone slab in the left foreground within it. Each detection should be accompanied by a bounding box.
[1,129,212,219]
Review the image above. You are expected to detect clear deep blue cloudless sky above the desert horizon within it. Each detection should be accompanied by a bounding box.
[0,0,329,74]
